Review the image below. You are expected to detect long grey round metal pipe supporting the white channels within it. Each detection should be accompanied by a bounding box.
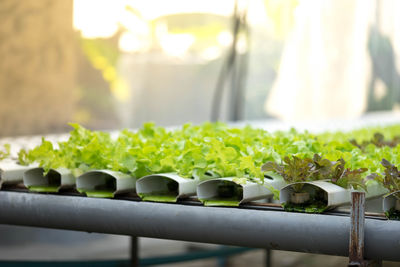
[0,194,400,261]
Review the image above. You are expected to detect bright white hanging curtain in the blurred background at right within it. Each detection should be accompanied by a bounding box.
[265,0,400,120]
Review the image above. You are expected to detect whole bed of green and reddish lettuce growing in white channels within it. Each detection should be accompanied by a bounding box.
[14,123,400,199]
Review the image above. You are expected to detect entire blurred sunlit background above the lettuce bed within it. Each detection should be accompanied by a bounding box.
[0,0,400,136]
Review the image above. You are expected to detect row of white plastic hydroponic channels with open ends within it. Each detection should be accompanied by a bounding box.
[0,161,400,218]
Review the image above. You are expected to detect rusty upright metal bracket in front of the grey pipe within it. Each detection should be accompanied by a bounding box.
[348,192,382,266]
